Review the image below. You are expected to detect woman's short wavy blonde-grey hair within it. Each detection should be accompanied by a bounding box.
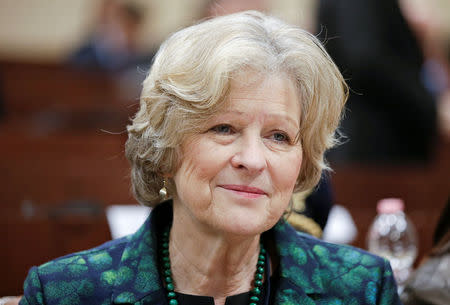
[125,11,348,206]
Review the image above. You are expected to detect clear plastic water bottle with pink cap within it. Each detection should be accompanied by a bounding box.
[367,198,418,291]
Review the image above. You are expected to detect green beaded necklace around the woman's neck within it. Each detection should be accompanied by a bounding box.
[161,226,266,305]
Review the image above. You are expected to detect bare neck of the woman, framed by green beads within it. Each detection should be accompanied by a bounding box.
[169,204,259,305]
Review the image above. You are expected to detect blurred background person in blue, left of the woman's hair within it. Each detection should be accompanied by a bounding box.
[68,0,151,71]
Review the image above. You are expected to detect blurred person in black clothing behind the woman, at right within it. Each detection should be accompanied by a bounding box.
[318,0,437,164]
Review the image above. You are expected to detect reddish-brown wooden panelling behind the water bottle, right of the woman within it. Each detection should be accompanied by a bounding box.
[332,139,450,264]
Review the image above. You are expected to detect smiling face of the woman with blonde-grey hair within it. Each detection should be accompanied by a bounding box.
[174,73,302,235]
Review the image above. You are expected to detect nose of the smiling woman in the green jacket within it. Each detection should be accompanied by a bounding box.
[231,136,267,173]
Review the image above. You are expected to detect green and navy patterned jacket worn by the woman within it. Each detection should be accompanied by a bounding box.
[20,203,401,305]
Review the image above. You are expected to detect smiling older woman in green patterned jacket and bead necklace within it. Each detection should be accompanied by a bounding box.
[21,12,398,305]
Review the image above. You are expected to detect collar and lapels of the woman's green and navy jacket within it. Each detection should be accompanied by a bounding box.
[112,202,323,304]
